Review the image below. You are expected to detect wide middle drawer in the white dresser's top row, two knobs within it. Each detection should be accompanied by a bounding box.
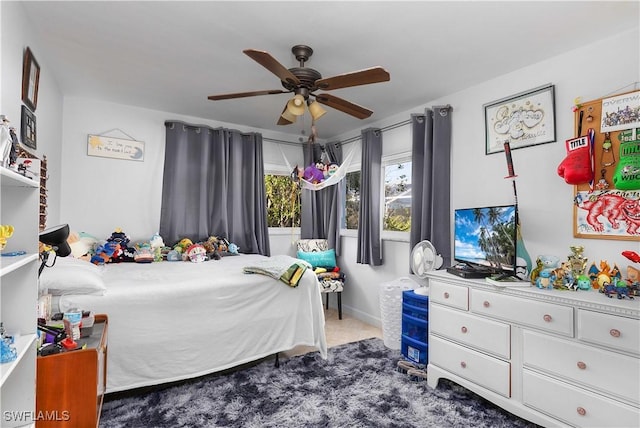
[469,289,573,337]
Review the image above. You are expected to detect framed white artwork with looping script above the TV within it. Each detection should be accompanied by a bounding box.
[483,84,556,155]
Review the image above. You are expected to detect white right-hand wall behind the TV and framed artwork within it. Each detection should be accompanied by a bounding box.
[341,28,640,323]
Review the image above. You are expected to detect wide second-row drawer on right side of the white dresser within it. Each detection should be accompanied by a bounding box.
[523,330,640,403]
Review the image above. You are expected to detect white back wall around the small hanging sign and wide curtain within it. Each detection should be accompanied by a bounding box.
[60,97,302,241]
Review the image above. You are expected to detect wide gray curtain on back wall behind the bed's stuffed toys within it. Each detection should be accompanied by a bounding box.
[160,121,271,255]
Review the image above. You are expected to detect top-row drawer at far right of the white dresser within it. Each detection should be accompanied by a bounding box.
[578,309,640,355]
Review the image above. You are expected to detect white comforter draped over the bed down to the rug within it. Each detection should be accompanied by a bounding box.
[59,255,327,392]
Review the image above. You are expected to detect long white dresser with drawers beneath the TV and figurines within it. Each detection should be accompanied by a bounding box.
[427,271,640,428]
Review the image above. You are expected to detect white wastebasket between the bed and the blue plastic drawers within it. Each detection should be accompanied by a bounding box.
[380,277,420,349]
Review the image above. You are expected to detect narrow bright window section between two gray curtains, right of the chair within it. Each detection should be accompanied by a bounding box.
[382,160,411,232]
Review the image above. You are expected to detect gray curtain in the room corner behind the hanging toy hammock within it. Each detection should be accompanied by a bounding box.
[300,143,344,256]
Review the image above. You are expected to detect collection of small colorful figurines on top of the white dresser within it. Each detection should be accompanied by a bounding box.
[529,246,640,300]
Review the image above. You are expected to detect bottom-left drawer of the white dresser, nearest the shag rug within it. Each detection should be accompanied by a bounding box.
[429,336,511,397]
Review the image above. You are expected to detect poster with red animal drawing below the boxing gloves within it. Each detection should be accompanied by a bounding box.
[573,190,640,241]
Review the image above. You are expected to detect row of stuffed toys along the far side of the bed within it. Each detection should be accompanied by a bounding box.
[68,228,239,265]
